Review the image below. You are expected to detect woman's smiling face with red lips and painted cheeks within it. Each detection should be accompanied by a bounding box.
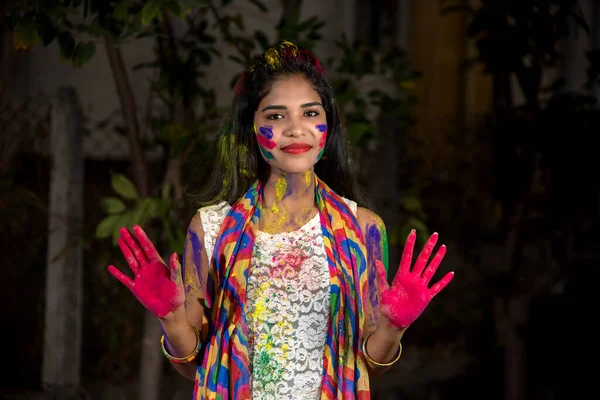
[254,76,327,174]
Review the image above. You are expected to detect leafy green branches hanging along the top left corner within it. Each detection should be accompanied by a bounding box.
[5,0,205,67]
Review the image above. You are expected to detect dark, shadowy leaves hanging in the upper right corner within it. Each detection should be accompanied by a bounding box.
[441,0,589,104]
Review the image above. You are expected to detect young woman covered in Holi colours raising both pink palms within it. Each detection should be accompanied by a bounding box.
[109,42,453,400]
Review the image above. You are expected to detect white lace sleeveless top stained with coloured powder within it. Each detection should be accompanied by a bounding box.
[199,200,356,400]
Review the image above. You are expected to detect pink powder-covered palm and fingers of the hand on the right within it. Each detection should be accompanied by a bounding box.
[376,229,454,330]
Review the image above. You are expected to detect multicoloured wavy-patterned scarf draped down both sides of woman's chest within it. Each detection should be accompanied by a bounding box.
[194,178,370,400]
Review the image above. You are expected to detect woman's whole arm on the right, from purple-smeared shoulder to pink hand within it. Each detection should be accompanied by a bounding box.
[358,209,454,377]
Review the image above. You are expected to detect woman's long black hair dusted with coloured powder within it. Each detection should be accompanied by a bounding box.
[195,41,368,206]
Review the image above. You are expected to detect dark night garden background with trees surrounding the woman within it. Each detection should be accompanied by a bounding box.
[0,0,600,400]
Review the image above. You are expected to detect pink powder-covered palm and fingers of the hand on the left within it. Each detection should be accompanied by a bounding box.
[108,225,185,319]
